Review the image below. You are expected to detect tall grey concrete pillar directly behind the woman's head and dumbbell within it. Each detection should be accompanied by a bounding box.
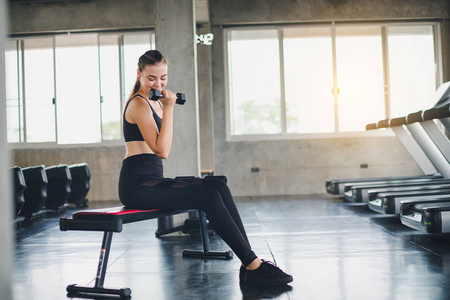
[155,0,200,177]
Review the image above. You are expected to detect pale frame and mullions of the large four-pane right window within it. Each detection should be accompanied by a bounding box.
[223,21,443,142]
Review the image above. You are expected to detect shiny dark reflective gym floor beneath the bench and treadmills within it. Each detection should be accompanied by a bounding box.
[13,195,450,300]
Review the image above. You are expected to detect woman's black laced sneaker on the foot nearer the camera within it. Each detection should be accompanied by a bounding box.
[244,260,293,286]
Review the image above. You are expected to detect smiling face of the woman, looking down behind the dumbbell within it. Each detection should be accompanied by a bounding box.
[138,63,167,95]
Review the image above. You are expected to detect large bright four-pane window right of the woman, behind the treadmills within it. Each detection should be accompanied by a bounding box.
[227,24,439,136]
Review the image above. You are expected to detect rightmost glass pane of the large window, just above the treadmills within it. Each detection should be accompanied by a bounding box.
[388,25,437,117]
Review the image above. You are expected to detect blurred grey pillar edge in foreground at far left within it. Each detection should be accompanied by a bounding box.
[0,0,13,299]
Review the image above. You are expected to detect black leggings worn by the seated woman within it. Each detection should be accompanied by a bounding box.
[119,154,257,266]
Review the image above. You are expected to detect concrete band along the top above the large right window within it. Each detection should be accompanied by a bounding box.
[209,0,448,25]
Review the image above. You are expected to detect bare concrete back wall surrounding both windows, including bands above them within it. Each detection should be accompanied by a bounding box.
[6,0,450,200]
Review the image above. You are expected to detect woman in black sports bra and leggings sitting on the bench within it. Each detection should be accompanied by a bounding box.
[119,50,292,285]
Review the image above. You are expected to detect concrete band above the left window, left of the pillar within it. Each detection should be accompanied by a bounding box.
[9,0,155,34]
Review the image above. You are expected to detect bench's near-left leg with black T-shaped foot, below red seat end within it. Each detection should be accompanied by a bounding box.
[67,231,131,297]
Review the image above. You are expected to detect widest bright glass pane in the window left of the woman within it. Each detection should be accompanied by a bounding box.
[56,34,101,144]
